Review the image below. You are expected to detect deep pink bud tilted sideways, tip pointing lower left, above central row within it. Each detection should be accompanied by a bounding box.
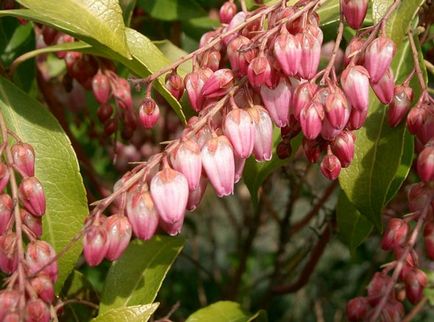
[201,69,234,98]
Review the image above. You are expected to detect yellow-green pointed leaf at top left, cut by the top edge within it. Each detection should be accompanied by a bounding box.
[15,0,131,59]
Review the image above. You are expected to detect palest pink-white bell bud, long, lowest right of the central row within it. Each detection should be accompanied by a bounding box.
[201,135,235,197]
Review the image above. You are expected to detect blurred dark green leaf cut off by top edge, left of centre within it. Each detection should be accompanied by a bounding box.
[139,0,207,21]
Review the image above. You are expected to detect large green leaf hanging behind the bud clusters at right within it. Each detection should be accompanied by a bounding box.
[339,3,419,230]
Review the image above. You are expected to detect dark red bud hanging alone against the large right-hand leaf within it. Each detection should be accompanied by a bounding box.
[387,85,413,127]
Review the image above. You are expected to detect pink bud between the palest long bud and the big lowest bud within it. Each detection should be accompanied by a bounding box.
[171,139,202,191]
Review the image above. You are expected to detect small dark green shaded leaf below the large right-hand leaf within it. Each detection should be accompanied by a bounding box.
[336,191,373,252]
